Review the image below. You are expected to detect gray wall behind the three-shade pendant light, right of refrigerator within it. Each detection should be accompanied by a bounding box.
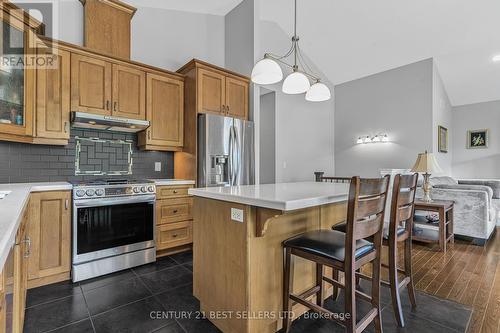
[259,21,334,183]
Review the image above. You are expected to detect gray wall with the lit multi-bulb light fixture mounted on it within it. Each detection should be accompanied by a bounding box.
[335,59,433,177]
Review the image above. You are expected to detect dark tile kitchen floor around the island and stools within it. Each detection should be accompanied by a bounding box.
[20,253,471,333]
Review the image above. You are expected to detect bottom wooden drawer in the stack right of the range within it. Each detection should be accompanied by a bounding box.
[156,221,193,251]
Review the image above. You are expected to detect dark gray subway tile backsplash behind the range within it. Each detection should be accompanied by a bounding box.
[0,129,174,183]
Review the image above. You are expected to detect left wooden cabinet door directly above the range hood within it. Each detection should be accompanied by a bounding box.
[71,53,112,116]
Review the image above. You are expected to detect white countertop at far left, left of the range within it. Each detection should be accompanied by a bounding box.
[0,182,72,270]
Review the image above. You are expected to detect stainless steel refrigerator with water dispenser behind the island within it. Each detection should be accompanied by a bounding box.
[198,114,255,187]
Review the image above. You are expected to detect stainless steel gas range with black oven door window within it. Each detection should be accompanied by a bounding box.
[72,180,156,282]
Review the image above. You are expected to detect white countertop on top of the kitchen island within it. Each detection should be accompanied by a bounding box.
[189,182,349,211]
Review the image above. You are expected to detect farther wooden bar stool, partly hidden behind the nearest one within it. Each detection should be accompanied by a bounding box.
[332,174,418,327]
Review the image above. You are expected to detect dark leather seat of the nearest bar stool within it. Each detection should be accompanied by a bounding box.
[283,230,375,262]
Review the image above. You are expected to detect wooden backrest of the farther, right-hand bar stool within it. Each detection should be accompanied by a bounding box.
[389,173,418,241]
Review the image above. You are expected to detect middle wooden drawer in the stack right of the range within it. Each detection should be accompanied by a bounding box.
[156,198,193,225]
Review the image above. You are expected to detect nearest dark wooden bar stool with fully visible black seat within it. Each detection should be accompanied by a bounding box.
[283,176,389,332]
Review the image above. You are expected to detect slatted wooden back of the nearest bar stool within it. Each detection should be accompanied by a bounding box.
[346,175,390,243]
